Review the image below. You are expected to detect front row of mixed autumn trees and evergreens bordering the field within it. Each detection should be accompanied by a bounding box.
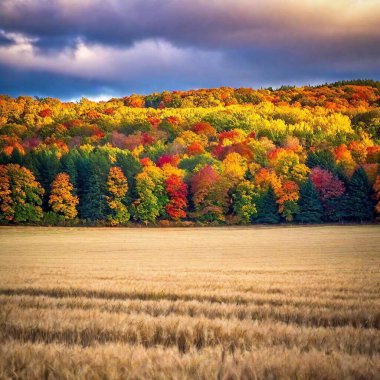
[0,147,380,225]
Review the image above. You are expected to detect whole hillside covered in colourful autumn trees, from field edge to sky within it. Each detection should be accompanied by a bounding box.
[0,81,380,225]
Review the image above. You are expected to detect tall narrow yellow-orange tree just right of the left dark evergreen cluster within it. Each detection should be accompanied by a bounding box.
[106,166,130,226]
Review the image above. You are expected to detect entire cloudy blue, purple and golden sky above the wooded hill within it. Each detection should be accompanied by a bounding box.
[0,0,380,100]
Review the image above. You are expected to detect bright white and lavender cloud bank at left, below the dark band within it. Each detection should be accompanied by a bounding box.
[0,33,230,81]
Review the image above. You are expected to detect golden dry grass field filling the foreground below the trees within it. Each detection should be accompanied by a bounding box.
[0,226,380,379]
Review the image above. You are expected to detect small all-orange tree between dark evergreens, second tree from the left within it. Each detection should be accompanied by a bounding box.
[49,173,79,219]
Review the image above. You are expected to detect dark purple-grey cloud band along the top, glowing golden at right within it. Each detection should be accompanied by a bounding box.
[0,0,380,48]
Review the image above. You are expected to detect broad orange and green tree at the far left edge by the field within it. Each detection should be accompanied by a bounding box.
[0,164,44,223]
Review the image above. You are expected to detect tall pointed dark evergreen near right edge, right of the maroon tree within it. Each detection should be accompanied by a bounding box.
[348,167,374,222]
